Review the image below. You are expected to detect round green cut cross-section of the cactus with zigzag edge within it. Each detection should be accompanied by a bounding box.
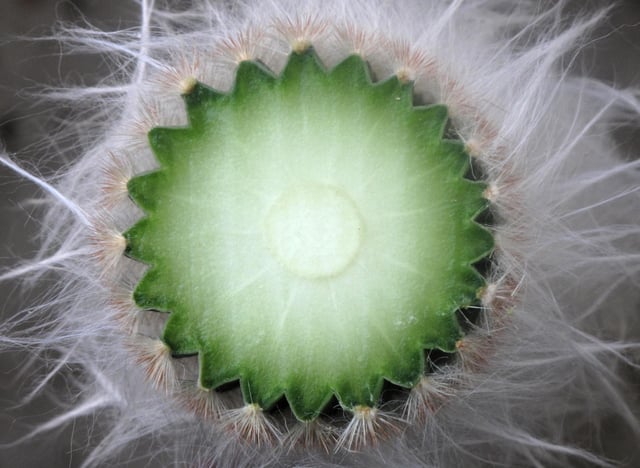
[125,49,493,421]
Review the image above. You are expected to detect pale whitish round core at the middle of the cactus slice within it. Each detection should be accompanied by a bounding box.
[265,184,363,279]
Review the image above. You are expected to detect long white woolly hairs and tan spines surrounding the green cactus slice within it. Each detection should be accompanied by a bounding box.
[0,0,640,467]
